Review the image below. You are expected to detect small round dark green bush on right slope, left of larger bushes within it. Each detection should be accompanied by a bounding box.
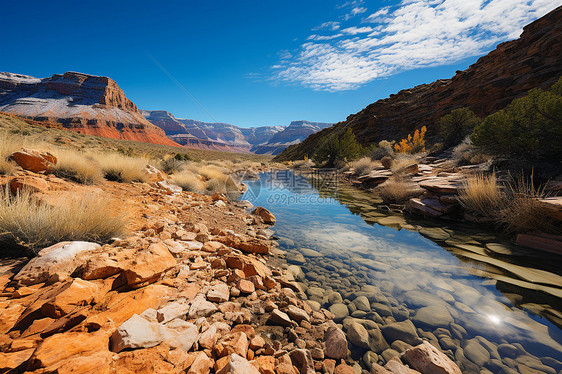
[439,108,480,147]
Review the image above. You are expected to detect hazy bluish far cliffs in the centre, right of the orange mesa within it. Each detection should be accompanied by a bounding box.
[141,110,333,155]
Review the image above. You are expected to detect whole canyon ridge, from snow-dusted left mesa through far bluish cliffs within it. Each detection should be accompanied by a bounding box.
[0,72,332,155]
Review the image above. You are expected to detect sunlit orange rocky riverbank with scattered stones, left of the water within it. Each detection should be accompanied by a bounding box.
[0,153,460,374]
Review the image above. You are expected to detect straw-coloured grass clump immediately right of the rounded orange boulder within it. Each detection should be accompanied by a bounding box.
[53,149,103,184]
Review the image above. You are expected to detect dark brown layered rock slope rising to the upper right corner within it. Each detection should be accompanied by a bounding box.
[279,7,562,160]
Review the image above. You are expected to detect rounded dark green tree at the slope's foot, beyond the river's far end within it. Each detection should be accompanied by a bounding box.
[314,128,365,167]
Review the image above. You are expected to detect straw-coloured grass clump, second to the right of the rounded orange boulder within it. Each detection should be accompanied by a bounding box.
[92,153,149,183]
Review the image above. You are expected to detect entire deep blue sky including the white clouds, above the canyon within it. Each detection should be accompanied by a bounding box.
[0,0,562,127]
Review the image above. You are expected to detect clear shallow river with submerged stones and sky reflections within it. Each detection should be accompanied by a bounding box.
[242,170,562,374]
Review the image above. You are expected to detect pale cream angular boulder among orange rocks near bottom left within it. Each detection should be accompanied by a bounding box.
[111,314,164,353]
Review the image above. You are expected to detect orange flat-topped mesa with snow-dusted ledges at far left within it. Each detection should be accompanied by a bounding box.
[0,72,177,146]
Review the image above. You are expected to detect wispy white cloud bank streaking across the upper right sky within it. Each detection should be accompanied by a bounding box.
[277,0,562,91]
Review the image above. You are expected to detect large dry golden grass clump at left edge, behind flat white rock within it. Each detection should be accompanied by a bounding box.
[0,189,127,253]
